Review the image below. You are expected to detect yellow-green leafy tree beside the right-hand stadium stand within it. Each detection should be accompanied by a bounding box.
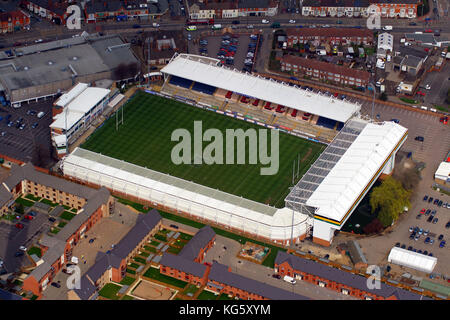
[370,177,411,227]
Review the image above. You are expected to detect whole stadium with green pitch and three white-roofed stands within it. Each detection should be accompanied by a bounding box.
[62,54,408,245]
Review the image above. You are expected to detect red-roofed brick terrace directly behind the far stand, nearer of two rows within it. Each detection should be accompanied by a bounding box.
[280,55,370,87]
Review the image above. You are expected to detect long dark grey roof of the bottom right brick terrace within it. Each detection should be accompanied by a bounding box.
[275,251,432,300]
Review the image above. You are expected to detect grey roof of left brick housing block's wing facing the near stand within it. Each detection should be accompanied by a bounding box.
[5,163,97,199]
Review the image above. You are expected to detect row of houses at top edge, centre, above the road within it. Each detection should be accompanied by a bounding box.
[188,0,278,20]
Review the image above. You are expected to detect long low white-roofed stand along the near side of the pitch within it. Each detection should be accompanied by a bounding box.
[63,148,311,240]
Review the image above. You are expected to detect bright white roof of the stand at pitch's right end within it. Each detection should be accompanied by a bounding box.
[306,120,408,222]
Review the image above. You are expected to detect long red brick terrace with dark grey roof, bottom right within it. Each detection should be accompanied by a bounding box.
[275,251,427,300]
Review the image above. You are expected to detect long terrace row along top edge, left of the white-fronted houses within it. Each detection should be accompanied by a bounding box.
[21,0,169,24]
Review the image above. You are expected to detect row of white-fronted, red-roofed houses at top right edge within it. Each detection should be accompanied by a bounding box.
[302,0,421,18]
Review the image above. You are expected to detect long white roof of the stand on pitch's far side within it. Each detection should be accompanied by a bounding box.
[161,54,361,122]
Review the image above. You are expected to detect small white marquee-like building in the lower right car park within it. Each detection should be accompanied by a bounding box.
[388,247,437,273]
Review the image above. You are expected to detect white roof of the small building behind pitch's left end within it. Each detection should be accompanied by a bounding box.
[50,87,110,130]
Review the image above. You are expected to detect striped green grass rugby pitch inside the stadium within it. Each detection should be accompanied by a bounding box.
[81,92,325,208]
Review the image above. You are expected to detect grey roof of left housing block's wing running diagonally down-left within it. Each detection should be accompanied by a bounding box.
[56,188,110,242]
